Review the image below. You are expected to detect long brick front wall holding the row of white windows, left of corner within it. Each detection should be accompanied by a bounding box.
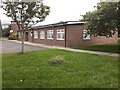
[28,26,65,47]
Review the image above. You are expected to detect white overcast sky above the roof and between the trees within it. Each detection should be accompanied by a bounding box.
[0,0,100,24]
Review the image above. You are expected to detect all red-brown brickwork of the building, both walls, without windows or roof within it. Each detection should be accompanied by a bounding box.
[18,25,117,47]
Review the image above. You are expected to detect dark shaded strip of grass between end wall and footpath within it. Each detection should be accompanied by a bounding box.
[76,43,120,53]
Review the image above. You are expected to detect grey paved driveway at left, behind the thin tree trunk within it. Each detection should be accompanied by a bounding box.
[0,40,46,54]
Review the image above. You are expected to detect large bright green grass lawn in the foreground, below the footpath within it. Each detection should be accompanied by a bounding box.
[2,49,118,88]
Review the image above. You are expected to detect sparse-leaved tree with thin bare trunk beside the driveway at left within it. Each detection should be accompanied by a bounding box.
[2,0,50,53]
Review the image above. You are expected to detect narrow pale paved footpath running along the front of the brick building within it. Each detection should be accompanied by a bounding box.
[10,40,120,57]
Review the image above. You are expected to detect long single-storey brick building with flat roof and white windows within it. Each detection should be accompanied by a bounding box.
[18,21,118,47]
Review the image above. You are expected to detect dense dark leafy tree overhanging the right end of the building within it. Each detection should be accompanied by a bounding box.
[83,2,120,37]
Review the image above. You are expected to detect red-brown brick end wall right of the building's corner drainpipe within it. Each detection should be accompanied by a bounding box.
[66,25,118,47]
